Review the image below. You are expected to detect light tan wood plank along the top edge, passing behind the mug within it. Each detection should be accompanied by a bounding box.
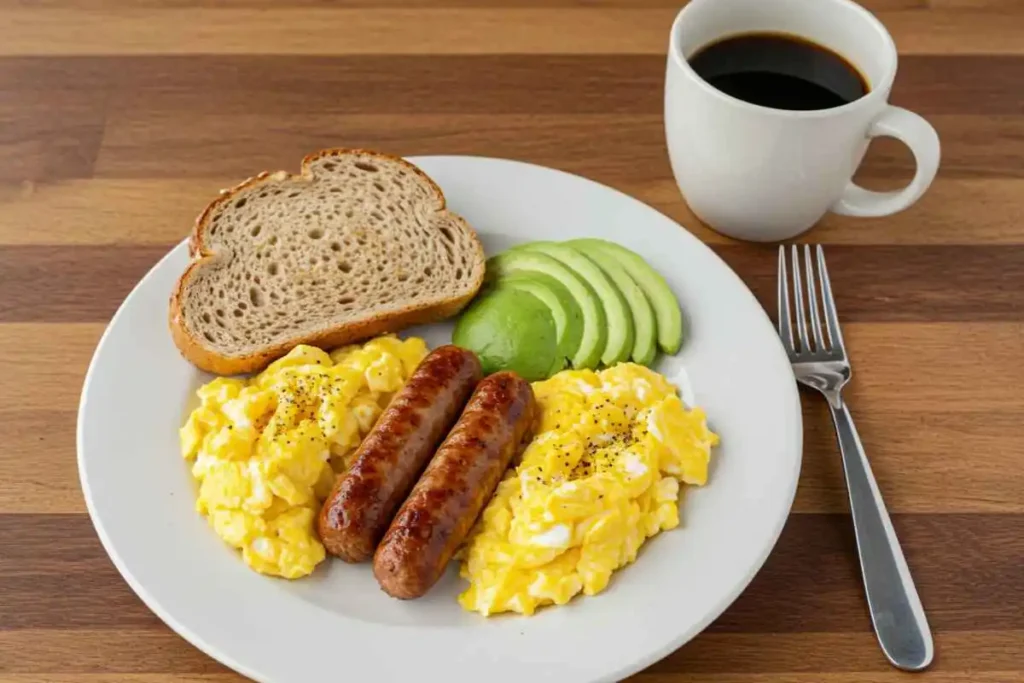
[0,6,1024,55]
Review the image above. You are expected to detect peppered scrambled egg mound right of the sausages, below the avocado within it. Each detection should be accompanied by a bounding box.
[459,364,718,615]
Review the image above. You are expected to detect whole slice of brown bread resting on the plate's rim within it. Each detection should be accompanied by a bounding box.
[170,150,484,375]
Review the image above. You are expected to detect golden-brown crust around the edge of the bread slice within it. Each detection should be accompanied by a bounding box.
[168,147,484,375]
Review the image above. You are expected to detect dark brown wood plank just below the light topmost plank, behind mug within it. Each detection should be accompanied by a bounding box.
[0,53,1024,116]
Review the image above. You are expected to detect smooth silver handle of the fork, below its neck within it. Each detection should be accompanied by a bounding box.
[829,396,935,671]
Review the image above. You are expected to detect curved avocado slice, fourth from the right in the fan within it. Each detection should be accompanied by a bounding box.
[485,249,607,369]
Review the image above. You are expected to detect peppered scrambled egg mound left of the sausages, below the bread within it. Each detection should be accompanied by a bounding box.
[180,336,427,579]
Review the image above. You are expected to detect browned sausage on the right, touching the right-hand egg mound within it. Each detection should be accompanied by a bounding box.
[374,372,536,599]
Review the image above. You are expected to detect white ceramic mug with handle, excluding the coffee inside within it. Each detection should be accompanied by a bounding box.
[665,0,939,242]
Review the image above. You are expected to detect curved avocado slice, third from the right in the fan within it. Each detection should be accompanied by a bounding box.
[514,242,634,366]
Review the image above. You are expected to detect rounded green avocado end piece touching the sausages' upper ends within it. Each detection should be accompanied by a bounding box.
[452,288,565,382]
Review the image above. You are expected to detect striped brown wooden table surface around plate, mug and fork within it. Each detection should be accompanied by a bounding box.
[0,0,1024,683]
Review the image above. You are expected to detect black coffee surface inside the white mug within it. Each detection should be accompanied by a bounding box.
[688,33,868,111]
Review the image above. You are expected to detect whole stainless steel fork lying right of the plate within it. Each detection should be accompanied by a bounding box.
[778,246,935,671]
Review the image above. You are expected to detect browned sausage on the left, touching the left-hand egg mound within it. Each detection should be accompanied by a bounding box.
[316,346,482,562]
